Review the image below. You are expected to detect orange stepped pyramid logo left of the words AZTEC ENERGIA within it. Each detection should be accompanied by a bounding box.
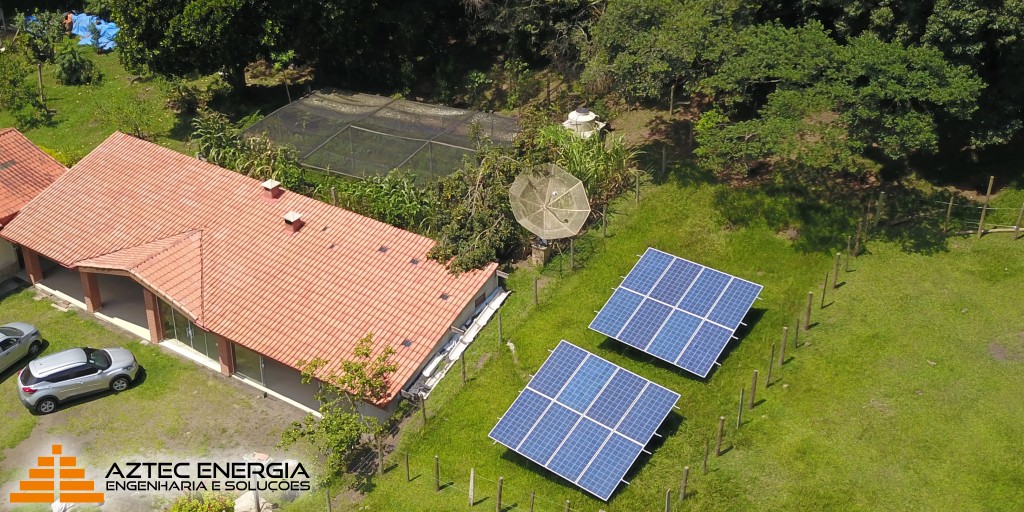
[10,444,103,503]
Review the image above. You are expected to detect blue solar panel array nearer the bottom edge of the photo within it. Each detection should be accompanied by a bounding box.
[488,340,679,501]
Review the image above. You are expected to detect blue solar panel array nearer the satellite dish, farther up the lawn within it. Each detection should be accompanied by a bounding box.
[590,248,762,378]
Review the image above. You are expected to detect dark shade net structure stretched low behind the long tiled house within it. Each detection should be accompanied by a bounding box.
[245,89,519,183]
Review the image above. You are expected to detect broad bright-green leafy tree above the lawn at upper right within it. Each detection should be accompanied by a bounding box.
[696,23,982,185]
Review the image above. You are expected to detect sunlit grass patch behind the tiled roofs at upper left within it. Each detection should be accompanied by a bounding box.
[0,47,190,164]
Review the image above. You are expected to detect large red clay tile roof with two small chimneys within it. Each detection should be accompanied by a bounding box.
[3,133,497,396]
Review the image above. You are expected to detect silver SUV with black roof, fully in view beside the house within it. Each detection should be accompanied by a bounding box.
[17,348,138,415]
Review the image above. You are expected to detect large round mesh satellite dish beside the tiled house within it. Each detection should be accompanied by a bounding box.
[509,164,590,240]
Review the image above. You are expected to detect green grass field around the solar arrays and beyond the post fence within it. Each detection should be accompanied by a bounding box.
[362,178,1024,512]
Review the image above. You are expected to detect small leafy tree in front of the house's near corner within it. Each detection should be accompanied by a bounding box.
[281,334,398,481]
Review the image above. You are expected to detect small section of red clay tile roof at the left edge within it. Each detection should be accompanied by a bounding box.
[0,128,68,225]
